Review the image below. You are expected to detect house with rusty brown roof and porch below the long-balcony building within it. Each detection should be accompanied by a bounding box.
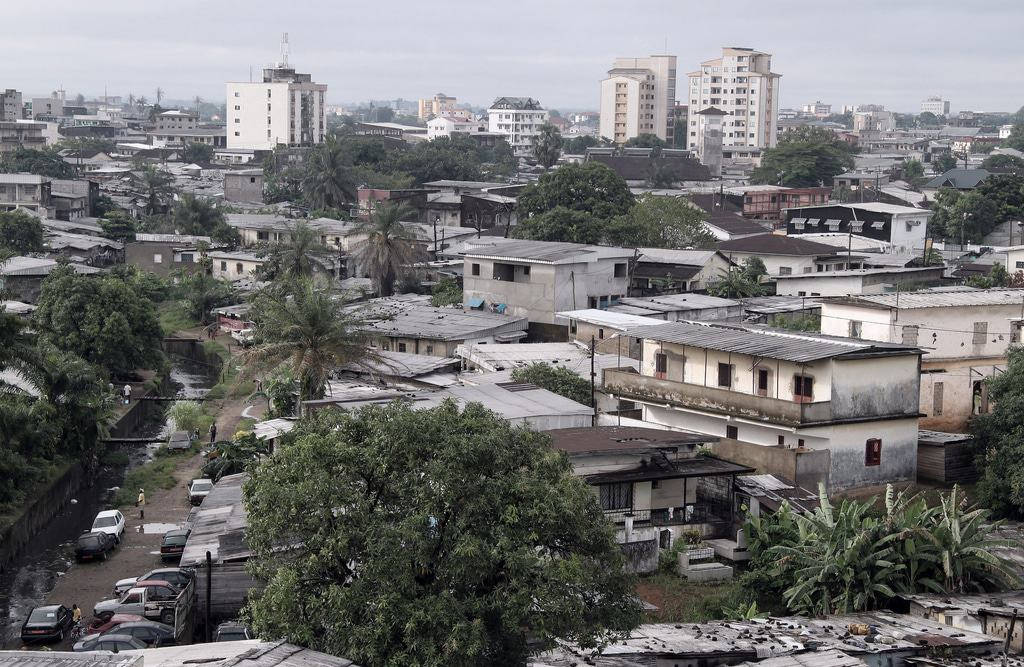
[548,426,753,572]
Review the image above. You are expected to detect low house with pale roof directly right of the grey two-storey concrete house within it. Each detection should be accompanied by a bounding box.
[630,248,735,296]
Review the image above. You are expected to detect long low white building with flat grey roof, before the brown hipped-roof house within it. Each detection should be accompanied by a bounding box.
[775,265,946,296]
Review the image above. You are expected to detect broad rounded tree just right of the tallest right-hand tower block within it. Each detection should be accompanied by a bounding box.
[751,127,854,187]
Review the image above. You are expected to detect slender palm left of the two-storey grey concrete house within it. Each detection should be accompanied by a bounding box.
[355,203,417,296]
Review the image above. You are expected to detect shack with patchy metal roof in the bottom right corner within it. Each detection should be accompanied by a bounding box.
[900,590,1024,654]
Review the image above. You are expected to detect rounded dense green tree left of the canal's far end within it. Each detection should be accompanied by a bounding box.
[33,266,163,376]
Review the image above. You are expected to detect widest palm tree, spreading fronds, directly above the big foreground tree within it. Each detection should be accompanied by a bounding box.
[244,280,379,401]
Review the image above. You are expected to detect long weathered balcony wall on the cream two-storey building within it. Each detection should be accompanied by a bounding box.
[604,369,833,426]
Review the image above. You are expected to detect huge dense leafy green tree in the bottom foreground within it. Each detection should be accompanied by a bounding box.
[243,401,641,667]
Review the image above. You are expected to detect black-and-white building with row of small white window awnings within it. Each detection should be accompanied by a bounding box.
[783,202,932,254]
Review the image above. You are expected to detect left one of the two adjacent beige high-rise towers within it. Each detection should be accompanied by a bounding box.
[600,55,676,145]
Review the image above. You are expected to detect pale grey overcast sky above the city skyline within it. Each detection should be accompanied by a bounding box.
[8,0,1024,112]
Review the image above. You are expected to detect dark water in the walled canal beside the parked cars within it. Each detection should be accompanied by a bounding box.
[0,359,216,648]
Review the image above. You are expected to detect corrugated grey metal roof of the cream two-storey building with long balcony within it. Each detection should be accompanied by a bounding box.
[630,322,921,364]
